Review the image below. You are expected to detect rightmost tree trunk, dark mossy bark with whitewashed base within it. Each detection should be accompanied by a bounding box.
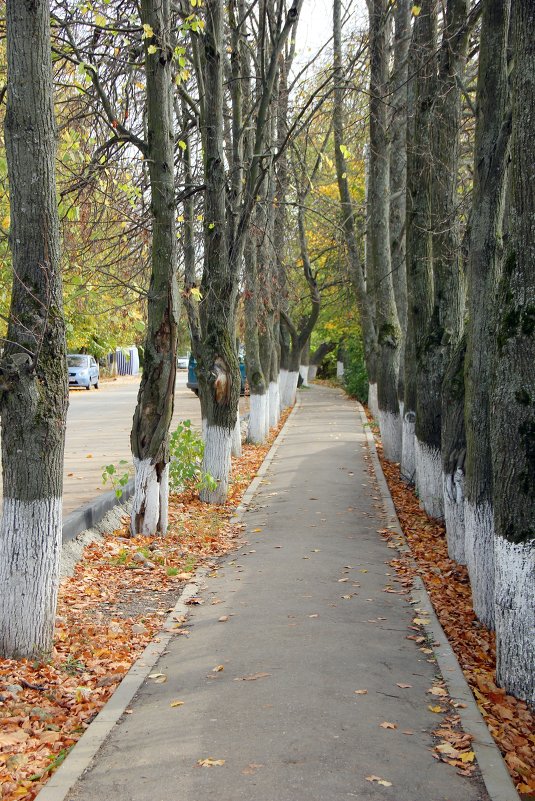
[490,0,535,707]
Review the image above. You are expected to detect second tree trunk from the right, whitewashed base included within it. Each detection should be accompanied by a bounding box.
[464,0,510,628]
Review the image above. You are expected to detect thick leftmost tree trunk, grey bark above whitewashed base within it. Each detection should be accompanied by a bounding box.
[0,0,68,658]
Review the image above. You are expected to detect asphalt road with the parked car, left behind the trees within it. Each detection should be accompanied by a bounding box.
[0,370,243,517]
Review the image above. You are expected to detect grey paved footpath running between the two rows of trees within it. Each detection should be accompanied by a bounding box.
[67,388,488,801]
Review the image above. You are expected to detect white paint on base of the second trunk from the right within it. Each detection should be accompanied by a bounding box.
[464,500,494,629]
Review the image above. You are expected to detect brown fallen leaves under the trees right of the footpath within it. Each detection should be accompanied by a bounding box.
[377,424,535,796]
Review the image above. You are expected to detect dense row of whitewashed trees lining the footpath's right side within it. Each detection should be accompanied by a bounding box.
[354,0,535,703]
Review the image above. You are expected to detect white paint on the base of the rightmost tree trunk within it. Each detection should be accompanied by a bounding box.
[494,536,535,708]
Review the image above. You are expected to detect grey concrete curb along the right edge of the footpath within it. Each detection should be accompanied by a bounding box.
[357,403,520,801]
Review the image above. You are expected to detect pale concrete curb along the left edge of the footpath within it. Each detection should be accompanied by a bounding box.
[35,400,300,801]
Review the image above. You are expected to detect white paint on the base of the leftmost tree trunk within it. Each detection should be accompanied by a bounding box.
[0,498,62,658]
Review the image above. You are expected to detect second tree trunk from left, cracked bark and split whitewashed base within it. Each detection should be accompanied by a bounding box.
[131,0,179,536]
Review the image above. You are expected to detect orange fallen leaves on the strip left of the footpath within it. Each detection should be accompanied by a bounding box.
[0,414,287,801]
